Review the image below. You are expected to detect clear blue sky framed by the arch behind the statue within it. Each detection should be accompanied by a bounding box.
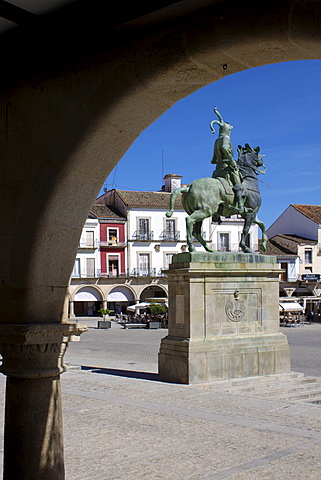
[100,60,321,227]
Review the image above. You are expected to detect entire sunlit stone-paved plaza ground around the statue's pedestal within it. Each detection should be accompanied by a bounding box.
[0,320,321,480]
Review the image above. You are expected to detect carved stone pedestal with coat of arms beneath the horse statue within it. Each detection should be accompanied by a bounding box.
[159,252,290,384]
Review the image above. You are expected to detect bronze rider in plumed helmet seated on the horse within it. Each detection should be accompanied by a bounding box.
[210,107,244,213]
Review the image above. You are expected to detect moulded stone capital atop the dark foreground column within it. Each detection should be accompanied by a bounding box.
[0,323,87,378]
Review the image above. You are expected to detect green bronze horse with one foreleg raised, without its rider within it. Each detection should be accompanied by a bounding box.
[166,144,267,253]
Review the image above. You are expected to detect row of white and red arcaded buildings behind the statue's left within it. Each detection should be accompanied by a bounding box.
[69,174,258,317]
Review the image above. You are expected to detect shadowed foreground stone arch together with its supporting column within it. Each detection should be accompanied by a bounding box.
[0,0,321,480]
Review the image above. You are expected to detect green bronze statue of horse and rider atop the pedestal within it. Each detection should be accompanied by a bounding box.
[166,107,267,253]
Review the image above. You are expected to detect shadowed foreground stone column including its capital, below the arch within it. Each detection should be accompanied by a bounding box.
[0,323,87,480]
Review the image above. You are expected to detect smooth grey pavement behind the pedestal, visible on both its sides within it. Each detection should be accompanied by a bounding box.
[65,318,321,377]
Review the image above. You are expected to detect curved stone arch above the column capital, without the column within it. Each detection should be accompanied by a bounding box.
[1,1,321,323]
